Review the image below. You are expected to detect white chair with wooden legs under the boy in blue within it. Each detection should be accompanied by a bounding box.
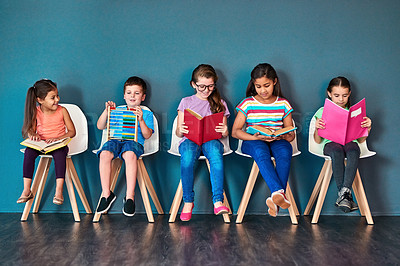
[93,106,164,223]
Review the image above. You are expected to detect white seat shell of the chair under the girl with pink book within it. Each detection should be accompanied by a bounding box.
[308,116,376,160]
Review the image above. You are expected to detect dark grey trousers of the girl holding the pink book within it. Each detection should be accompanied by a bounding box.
[324,142,360,191]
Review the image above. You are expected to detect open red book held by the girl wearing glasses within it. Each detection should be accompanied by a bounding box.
[184,109,224,145]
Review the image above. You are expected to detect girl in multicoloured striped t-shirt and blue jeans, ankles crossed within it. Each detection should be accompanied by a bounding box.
[232,63,294,217]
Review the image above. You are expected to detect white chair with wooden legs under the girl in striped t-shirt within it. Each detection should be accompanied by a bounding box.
[235,120,301,224]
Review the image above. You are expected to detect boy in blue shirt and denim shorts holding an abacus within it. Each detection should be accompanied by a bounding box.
[96,77,154,216]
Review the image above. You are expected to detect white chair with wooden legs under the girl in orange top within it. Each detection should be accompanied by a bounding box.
[21,104,92,222]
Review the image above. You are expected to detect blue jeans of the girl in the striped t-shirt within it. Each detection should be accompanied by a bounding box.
[242,139,293,193]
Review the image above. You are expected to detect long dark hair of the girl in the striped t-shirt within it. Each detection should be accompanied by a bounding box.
[246,63,283,98]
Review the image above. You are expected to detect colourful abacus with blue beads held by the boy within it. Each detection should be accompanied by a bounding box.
[107,106,138,141]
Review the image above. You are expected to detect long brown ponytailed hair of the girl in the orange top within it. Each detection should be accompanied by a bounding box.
[22,79,57,138]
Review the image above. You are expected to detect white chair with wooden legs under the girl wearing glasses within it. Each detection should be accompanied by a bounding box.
[168,117,232,223]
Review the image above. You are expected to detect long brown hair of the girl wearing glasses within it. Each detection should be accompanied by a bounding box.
[190,64,225,114]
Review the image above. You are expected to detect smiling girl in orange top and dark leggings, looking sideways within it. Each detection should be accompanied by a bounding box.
[17,79,75,205]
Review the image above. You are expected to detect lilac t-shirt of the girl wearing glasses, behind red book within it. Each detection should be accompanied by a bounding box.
[178,95,230,144]
